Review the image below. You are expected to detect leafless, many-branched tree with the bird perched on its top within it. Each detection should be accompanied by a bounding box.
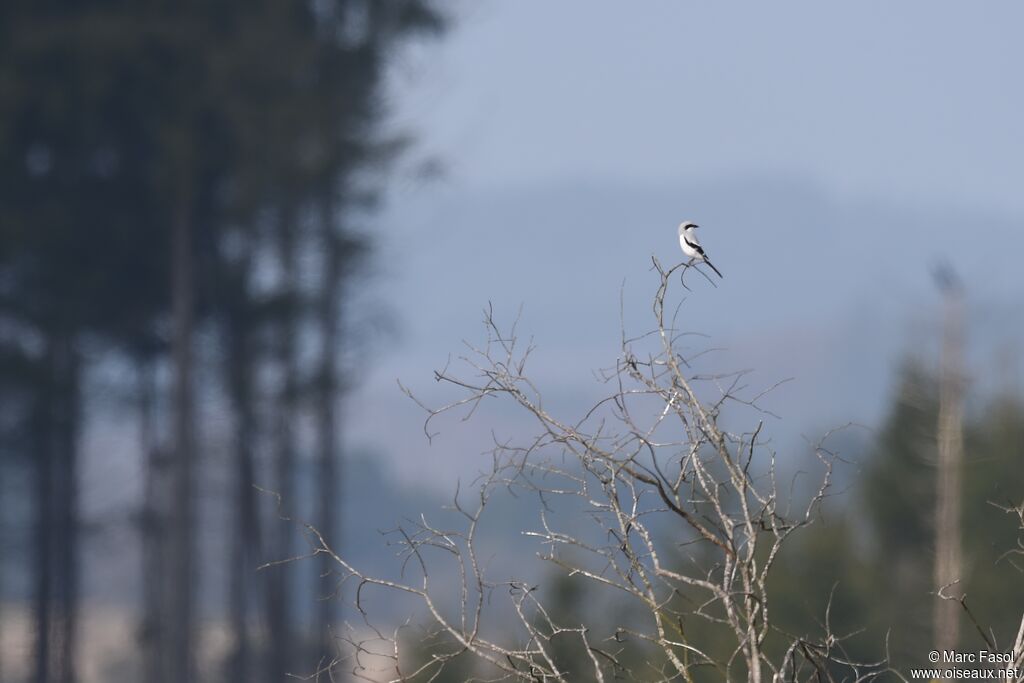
[278,259,884,681]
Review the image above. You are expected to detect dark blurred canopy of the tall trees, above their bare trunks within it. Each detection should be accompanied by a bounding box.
[0,0,440,344]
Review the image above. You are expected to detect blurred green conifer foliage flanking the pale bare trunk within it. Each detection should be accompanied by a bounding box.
[774,362,1024,671]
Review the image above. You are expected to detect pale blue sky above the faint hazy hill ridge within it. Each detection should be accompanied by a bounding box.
[387,0,1024,210]
